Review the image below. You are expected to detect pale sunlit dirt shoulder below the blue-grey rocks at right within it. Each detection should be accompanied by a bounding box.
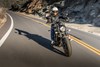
[66,23,100,36]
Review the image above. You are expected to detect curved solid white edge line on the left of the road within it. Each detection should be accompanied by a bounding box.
[0,13,14,47]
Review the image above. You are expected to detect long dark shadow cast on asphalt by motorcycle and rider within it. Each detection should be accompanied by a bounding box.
[15,28,65,56]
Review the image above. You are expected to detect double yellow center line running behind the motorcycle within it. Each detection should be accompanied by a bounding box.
[19,12,100,56]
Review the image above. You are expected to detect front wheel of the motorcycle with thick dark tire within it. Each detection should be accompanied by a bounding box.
[63,37,72,57]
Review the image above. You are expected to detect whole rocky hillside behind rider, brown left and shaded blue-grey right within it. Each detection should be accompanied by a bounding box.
[1,0,100,26]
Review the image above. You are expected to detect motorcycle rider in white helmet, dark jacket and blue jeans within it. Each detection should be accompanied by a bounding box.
[51,7,59,45]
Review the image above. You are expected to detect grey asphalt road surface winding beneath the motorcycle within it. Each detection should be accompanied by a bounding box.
[0,12,100,67]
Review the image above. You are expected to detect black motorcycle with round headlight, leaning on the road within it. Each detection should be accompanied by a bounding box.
[52,17,72,57]
